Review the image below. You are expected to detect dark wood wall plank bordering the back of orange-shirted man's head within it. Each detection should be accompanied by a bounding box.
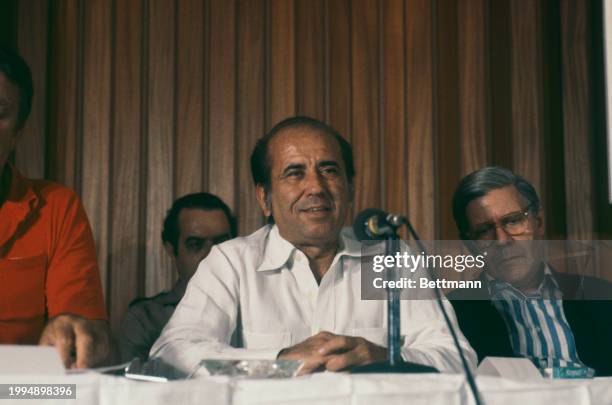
[15,0,49,178]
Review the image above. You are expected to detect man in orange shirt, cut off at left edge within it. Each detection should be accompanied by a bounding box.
[0,48,110,368]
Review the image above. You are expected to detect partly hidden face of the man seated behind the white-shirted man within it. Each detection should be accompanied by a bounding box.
[165,208,230,282]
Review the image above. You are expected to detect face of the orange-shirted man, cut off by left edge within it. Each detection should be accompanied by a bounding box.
[0,73,19,173]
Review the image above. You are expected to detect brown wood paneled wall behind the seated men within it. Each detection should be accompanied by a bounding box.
[3,0,609,326]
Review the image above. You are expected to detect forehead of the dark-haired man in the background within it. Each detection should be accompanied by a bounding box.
[178,208,230,238]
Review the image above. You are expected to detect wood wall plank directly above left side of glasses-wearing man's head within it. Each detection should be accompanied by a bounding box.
[457,0,490,175]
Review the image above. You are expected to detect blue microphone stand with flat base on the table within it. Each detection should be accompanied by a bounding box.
[351,227,438,374]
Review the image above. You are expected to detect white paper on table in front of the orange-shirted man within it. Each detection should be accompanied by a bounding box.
[0,345,64,375]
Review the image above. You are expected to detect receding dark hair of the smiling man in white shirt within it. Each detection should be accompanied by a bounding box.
[251,116,355,192]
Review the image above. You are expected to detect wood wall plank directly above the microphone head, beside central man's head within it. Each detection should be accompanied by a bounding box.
[351,0,383,212]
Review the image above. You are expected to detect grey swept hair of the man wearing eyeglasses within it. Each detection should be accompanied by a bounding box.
[453,166,540,239]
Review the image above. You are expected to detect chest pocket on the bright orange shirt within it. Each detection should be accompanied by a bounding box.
[0,253,47,321]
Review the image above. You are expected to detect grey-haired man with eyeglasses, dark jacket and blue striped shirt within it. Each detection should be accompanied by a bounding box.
[448,167,612,375]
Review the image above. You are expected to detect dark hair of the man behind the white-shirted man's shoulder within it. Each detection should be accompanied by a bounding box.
[162,193,236,253]
